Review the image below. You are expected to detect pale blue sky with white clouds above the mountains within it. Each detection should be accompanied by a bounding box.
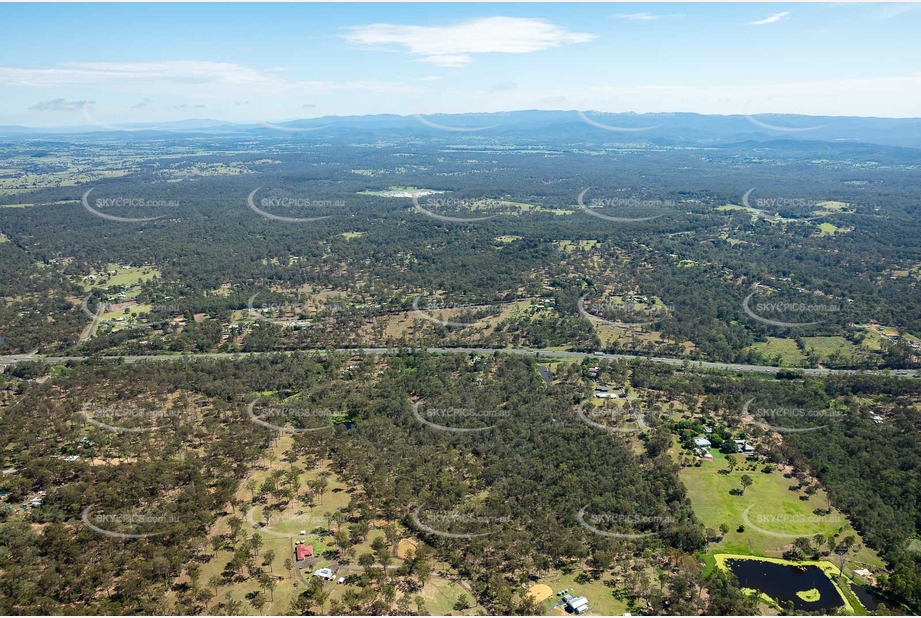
[0,3,921,126]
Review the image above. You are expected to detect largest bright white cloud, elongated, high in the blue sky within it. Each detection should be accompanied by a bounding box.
[344,17,595,66]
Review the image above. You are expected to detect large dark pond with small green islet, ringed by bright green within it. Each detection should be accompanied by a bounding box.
[726,558,844,612]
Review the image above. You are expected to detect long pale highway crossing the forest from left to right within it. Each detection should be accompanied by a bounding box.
[0,347,921,378]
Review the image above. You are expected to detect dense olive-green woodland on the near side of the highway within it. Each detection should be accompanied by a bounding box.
[0,351,752,614]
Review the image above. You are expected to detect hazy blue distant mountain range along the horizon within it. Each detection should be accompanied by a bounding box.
[0,110,921,148]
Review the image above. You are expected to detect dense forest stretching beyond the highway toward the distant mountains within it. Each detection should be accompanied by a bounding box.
[0,138,921,369]
